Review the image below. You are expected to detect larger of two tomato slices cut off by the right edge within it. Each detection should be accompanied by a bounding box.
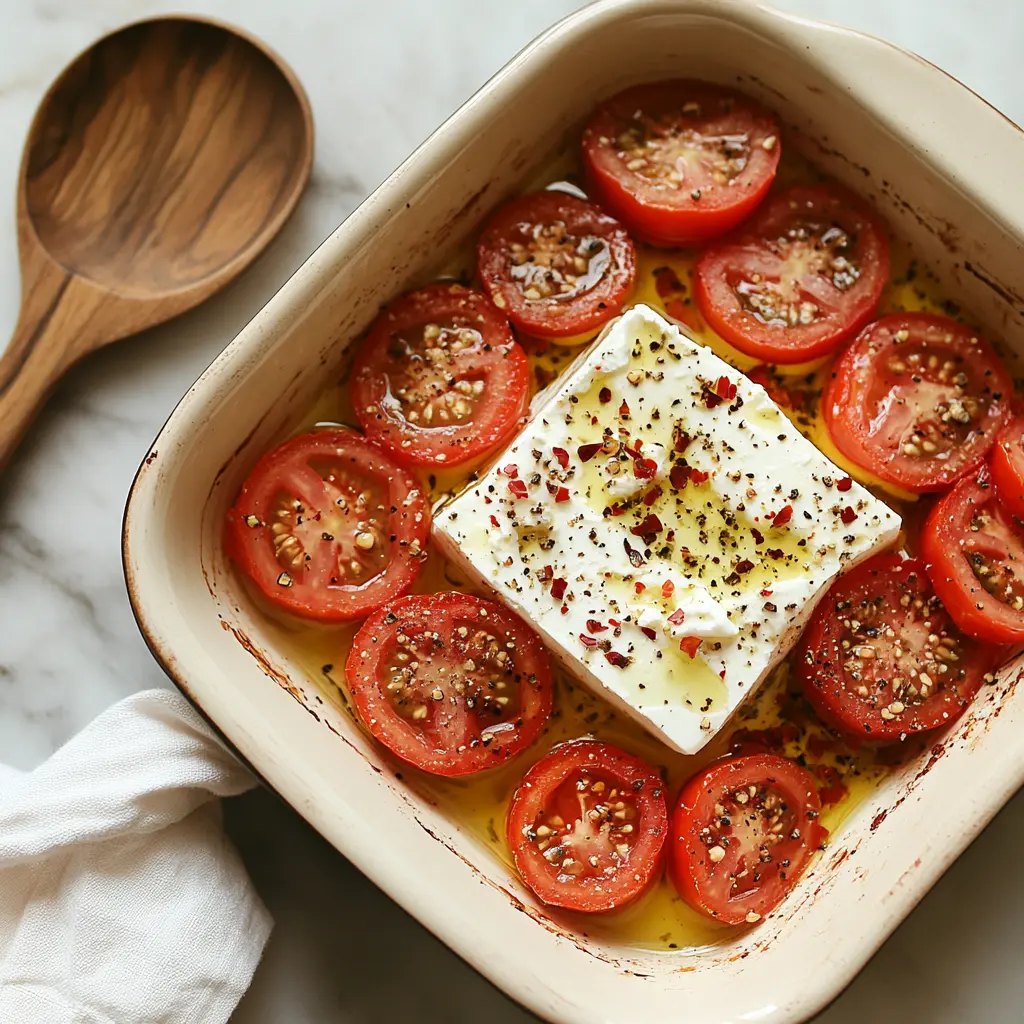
[921,469,1024,644]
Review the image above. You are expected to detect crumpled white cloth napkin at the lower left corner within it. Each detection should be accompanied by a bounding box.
[0,690,271,1024]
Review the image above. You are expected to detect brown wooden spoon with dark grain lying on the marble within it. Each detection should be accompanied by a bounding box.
[0,17,313,466]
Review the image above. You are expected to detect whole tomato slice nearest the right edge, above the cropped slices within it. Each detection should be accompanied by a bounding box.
[821,312,1013,493]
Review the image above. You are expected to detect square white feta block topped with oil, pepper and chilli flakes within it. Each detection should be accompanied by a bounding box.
[434,305,900,754]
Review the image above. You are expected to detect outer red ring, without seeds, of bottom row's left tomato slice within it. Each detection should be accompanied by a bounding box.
[507,739,669,913]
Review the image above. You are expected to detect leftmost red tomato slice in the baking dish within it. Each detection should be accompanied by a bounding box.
[224,429,430,623]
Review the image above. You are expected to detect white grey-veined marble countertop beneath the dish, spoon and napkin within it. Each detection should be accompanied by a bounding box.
[0,0,1024,1024]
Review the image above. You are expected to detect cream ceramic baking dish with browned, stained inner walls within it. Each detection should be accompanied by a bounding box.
[124,0,1024,1024]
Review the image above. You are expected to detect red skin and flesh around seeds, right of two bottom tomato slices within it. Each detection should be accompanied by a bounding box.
[668,754,828,925]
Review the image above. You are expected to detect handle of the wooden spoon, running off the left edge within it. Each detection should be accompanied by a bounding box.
[0,254,102,469]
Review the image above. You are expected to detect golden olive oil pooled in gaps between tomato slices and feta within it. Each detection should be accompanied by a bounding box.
[241,144,1007,952]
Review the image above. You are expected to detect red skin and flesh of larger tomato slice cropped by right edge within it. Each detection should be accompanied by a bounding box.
[921,468,1024,644]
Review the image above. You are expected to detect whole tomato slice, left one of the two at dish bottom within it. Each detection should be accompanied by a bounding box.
[508,739,669,913]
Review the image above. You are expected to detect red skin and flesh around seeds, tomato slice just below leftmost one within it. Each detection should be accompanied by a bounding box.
[345,591,553,777]
